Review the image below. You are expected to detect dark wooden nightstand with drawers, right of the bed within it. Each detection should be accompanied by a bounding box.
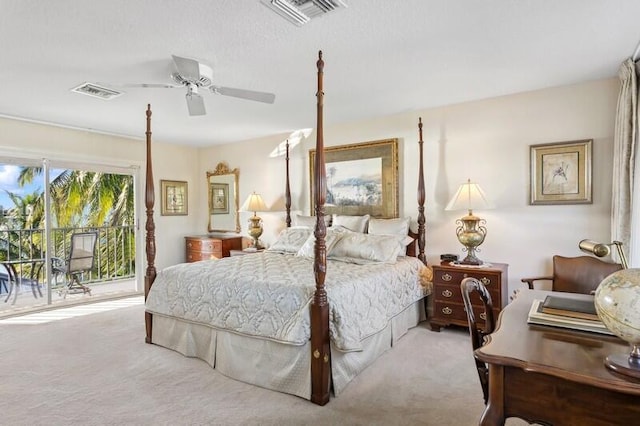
[430,262,509,331]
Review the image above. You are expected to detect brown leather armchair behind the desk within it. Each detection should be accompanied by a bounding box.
[521,255,622,294]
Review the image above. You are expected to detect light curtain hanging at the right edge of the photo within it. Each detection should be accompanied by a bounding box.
[611,58,640,267]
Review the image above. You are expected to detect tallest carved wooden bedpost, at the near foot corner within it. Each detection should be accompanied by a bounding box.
[311,51,331,405]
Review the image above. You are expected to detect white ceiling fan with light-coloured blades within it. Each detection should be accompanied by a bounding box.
[107,55,276,115]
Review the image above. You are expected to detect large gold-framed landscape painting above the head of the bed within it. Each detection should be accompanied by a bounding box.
[309,139,399,218]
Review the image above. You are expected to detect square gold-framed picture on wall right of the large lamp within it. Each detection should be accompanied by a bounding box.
[530,139,593,205]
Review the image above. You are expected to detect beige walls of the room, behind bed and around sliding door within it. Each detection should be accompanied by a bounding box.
[0,79,618,289]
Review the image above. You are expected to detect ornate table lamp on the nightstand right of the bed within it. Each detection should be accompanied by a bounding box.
[445,179,493,265]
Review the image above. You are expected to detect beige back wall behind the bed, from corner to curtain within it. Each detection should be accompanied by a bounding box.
[199,79,618,289]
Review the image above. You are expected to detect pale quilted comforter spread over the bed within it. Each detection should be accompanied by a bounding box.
[146,252,426,351]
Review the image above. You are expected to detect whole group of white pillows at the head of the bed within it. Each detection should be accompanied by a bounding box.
[268,214,413,264]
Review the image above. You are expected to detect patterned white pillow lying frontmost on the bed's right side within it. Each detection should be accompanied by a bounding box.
[328,231,400,264]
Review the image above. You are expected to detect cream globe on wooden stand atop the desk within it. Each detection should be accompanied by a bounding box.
[595,269,640,378]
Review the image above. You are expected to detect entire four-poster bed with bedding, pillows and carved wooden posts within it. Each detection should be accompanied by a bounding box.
[145,52,431,405]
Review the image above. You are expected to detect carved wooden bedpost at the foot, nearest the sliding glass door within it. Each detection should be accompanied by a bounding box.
[144,104,156,343]
